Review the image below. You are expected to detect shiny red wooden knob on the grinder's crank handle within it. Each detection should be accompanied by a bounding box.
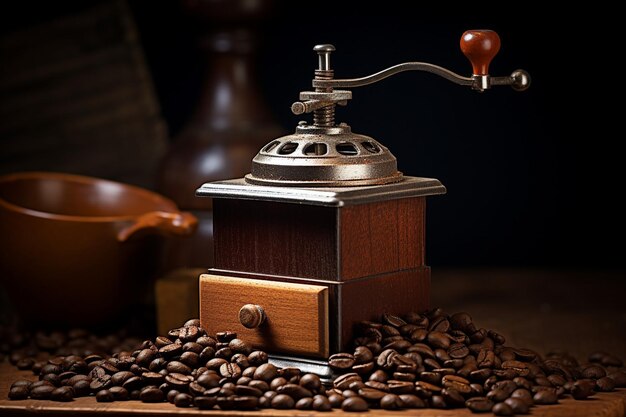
[461,29,500,75]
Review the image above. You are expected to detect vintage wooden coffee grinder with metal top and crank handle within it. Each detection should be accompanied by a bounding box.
[196,30,530,378]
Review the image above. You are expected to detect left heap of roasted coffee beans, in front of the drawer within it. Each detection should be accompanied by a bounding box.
[9,319,331,411]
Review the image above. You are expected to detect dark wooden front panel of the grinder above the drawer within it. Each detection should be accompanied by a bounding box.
[213,199,338,280]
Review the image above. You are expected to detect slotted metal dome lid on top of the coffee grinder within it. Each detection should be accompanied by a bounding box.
[246,123,402,187]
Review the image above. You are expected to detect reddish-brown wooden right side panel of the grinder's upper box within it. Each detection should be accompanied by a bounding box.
[339,197,425,280]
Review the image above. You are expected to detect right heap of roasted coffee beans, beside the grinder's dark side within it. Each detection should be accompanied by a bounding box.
[327,309,626,416]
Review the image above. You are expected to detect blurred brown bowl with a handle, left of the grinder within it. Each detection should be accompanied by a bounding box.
[0,172,197,326]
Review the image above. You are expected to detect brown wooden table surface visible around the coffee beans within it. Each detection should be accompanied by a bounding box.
[0,270,626,417]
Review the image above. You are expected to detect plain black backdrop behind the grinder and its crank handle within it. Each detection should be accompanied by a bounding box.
[0,0,626,269]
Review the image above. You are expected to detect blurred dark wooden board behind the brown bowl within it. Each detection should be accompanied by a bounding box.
[0,1,167,187]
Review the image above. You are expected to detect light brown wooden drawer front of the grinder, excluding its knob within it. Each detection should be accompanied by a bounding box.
[200,274,329,357]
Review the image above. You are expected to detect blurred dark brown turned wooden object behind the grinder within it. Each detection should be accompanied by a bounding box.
[158,0,281,268]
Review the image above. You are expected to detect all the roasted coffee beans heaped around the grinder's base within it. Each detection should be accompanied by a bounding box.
[9,309,626,415]
